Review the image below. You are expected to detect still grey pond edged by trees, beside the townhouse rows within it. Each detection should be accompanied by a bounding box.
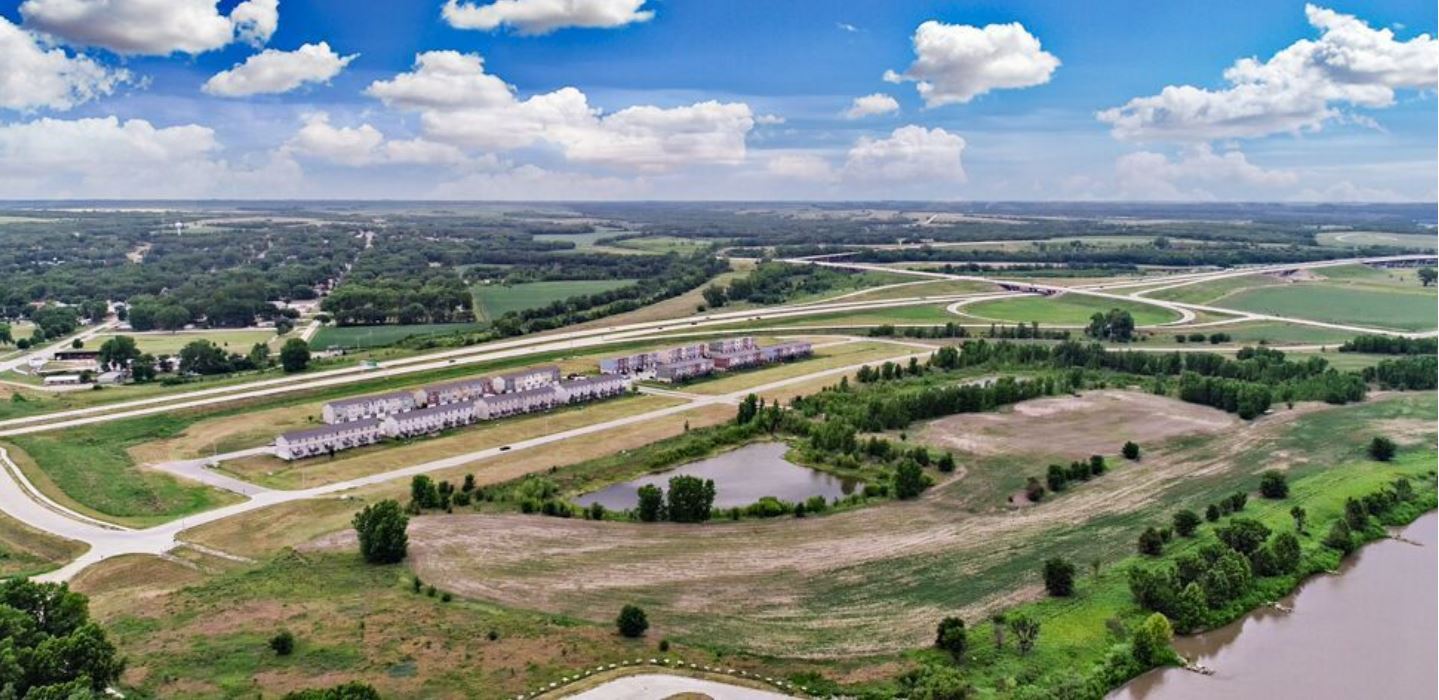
[576,442,858,510]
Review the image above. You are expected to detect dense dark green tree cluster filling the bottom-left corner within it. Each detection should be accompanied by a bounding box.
[0,579,125,699]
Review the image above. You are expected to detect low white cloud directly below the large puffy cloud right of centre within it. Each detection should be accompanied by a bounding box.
[843,124,966,181]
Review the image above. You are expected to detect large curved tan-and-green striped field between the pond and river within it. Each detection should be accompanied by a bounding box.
[297,393,1435,658]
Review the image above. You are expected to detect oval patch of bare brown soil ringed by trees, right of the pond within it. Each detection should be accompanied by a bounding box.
[920,390,1240,459]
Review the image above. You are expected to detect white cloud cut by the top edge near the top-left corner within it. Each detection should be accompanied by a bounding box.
[20,0,279,56]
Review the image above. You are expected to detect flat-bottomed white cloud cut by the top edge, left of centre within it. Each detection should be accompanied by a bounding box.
[440,0,655,35]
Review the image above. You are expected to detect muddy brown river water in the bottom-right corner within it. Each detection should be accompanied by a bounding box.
[1109,513,1439,700]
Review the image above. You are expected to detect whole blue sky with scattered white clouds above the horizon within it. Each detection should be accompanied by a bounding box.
[0,0,1439,202]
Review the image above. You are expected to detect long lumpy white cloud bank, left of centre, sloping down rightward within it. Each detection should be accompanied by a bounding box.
[366,52,755,171]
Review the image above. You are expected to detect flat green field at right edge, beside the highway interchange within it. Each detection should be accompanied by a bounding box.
[1223,284,1439,330]
